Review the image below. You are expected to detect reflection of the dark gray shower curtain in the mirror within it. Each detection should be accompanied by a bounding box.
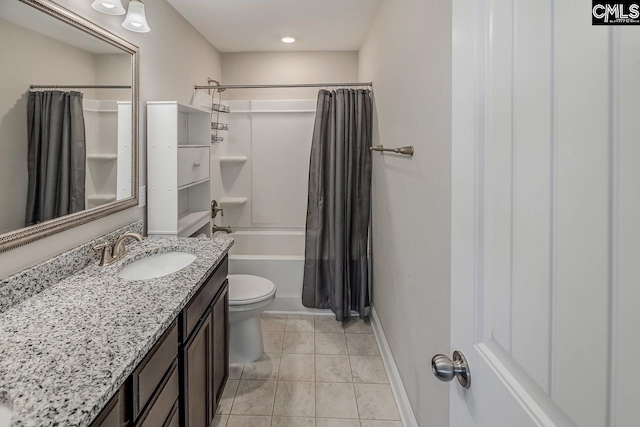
[26,91,86,226]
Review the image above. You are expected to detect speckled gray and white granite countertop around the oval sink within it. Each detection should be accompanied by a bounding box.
[0,237,233,427]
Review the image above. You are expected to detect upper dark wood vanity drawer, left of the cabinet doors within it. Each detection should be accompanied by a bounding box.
[132,322,178,420]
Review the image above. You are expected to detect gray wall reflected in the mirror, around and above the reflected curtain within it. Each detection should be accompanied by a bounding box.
[0,19,96,234]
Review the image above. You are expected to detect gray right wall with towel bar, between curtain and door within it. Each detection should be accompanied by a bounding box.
[360,0,451,427]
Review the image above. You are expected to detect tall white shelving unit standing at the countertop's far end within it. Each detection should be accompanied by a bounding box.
[147,101,211,237]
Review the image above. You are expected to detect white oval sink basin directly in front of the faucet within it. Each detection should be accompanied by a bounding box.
[118,252,197,282]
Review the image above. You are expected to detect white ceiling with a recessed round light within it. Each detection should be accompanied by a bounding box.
[168,0,381,52]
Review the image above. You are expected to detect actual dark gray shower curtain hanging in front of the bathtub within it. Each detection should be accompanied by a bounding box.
[302,89,372,320]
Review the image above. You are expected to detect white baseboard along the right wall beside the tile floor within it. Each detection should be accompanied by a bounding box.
[370,307,418,427]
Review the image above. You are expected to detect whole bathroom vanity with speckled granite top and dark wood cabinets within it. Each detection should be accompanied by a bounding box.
[0,229,233,427]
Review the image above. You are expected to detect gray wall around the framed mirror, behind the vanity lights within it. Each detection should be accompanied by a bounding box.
[0,0,222,277]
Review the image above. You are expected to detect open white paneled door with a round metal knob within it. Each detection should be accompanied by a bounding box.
[450,0,640,427]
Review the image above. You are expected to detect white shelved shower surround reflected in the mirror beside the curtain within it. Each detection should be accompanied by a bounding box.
[83,98,131,209]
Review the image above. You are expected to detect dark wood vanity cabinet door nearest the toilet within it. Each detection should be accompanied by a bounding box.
[211,282,229,414]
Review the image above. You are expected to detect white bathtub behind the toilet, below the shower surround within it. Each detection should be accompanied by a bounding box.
[225,231,329,314]
